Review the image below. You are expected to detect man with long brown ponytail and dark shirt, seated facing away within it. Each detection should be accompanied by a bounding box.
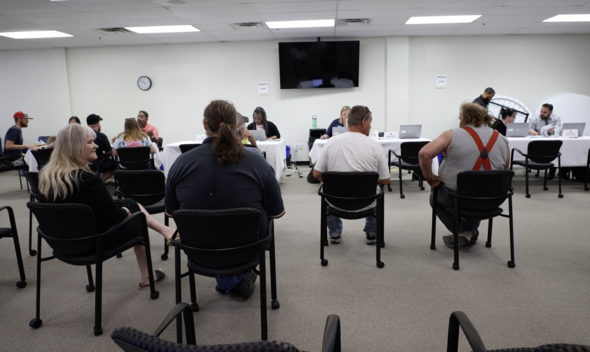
[166,100,285,299]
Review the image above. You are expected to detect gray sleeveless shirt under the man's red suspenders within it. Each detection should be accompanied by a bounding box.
[438,125,510,191]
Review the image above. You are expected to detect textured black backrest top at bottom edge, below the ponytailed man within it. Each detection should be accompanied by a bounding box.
[111,328,299,352]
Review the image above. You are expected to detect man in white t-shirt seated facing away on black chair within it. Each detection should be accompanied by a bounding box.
[313,105,390,245]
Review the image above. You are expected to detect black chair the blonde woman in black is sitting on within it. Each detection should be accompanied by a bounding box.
[27,202,159,335]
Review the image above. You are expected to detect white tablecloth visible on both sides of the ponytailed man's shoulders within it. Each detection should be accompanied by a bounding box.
[162,140,287,181]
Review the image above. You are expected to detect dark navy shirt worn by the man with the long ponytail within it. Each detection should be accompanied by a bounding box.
[166,138,285,234]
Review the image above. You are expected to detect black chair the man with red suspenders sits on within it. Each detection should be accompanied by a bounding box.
[430,170,515,270]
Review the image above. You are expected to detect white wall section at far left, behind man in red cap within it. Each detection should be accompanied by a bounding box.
[0,49,71,148]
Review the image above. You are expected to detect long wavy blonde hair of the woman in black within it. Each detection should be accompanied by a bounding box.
[39,123,96,201]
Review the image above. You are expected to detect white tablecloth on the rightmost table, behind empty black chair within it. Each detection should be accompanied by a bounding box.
[508,136,590,167]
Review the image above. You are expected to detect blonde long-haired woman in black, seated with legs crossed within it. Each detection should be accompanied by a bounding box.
[39,123,174,289]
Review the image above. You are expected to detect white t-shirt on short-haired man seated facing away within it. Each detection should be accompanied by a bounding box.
[314,132,390,211]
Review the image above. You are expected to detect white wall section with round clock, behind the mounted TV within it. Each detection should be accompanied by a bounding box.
[67,38,386,160]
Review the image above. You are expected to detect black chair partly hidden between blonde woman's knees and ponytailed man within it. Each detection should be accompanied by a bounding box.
[115,170,169,260]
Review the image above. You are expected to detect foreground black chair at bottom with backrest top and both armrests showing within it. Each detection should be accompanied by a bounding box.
[111,303,341,352]
